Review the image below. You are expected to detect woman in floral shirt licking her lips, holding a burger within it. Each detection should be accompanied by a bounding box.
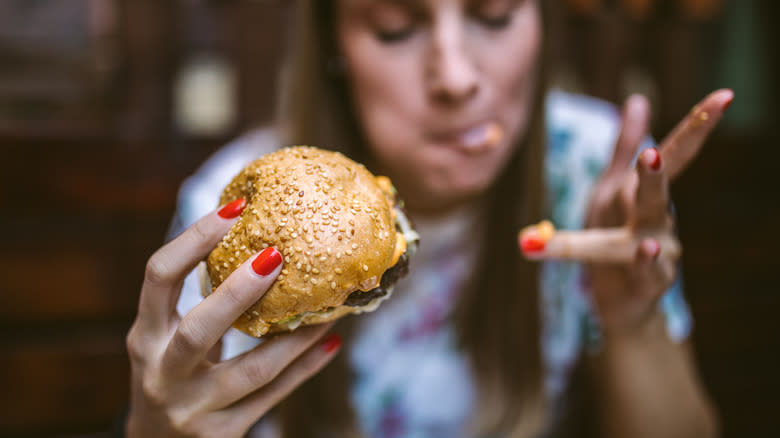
[126,0,733,437]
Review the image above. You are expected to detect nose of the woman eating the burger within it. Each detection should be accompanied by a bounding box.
[426,21,479,105]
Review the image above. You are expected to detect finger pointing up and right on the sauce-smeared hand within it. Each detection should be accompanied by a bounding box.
[659,89,734,180]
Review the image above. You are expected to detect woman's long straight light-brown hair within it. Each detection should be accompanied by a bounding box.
[276,0,548,438]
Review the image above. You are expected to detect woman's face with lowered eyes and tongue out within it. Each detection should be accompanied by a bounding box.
[337,0,541,213]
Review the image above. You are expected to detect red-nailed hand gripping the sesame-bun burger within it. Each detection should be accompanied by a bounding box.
[126,200,341,437]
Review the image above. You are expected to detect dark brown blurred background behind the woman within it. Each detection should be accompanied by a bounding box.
[0,0,780,437]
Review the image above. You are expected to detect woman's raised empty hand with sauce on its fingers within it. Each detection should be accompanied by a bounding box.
[519,90,733,335]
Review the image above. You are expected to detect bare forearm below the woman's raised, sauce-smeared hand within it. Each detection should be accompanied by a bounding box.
[590,312,717,438]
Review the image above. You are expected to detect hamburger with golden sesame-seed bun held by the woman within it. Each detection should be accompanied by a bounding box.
[201,146,419,337]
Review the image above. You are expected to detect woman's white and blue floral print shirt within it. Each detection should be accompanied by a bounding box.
[171,91,691,438]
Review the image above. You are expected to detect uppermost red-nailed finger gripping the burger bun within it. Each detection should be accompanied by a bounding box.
[138,199,246,332]
